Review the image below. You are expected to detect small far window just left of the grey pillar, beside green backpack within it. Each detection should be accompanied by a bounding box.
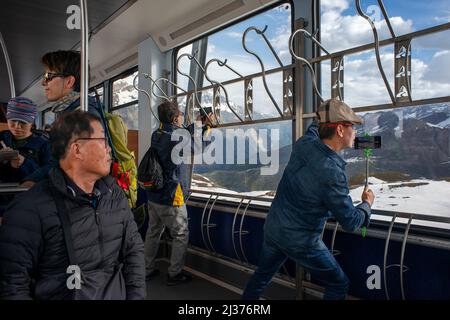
[111,70,139,130]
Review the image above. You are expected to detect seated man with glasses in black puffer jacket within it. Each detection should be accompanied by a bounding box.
[0,111,145,299]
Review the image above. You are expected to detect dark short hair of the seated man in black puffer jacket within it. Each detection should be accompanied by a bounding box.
[50,111,101,161]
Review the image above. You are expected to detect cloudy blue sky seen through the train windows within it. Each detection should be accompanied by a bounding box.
[174,0,450,116]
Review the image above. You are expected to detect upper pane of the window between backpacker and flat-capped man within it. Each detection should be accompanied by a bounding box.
[177,3,292,90]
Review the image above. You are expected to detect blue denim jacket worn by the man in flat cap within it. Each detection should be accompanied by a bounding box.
[264,123,370,248]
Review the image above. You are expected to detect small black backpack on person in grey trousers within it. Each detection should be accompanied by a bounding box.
[137,147,164,191]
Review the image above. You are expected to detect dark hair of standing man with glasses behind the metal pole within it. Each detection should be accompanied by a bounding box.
[41,50,81,92]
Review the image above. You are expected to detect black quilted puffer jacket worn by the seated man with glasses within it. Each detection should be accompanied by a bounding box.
[0,168,145,299]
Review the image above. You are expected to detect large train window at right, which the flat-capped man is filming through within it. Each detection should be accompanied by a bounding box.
[316,0,450,225]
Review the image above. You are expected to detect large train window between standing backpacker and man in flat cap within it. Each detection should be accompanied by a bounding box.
[175,3,293,197]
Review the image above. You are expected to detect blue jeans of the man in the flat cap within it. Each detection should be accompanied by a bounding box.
[242,238,349,300]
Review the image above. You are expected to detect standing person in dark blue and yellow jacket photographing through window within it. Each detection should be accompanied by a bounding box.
[145,101,212,286]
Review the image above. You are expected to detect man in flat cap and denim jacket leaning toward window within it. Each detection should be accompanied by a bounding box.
[243,99,374,299]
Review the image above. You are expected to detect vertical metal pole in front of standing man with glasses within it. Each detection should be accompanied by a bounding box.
[80,0,89,111]
